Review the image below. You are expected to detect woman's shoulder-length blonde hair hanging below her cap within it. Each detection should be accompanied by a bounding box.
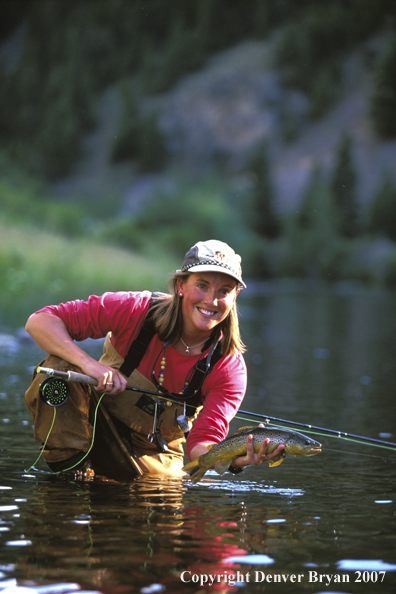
[151,273,245,356]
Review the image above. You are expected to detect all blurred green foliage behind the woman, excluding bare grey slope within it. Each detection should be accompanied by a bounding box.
[0,0,396,321]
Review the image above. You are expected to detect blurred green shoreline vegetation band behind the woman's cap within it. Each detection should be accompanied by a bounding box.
[0,169,396,328]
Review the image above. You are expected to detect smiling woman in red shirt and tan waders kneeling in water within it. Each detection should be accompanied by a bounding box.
[26,240,283,474]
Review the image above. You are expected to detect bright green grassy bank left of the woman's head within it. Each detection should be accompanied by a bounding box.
[0,219,179,328]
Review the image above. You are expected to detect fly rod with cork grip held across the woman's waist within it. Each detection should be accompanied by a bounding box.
[36,367,396,448]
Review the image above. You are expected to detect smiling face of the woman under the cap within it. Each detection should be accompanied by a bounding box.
[178,272,239,335]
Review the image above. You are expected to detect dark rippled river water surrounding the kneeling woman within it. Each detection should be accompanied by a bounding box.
[0,284,396,594]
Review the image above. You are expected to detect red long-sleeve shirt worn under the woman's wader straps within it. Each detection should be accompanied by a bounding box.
[40,291,247,456]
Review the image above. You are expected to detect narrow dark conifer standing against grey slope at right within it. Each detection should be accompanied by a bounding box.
[330,135,359,237]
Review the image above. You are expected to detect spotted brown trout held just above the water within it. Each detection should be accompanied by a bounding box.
[183,427,322,483]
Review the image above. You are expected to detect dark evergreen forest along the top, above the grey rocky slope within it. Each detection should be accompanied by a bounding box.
[0,0,396,178]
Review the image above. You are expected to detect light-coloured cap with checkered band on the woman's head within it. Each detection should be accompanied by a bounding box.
[176,239,246,288]
